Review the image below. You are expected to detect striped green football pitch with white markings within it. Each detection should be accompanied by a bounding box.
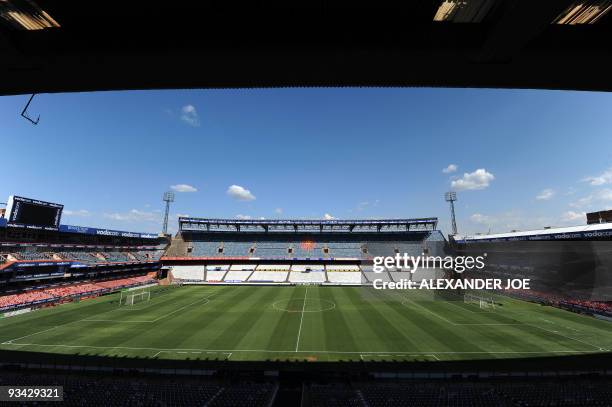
[0,286,612,362]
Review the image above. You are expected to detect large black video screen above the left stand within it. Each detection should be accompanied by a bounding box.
[7,196,64,230]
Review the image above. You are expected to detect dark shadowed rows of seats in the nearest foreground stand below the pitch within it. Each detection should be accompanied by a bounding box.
[0,371,612,407]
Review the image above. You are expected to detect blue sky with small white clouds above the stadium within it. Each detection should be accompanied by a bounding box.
[0,89,612,233]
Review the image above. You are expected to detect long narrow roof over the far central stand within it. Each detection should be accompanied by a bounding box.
[179,217,438,233]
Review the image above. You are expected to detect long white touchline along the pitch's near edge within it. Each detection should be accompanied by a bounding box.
[2,343,604,355]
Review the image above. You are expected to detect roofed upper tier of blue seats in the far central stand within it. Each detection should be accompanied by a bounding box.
[167,218,446,260]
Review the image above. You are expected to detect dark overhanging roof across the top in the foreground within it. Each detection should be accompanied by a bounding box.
[0,0,612,95]
